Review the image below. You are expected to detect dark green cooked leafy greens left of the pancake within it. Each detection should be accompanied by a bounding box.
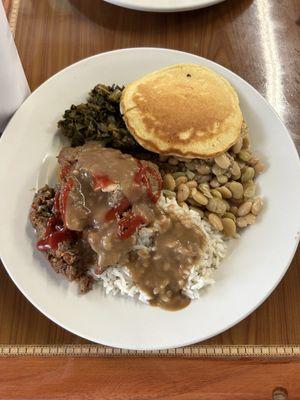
[58,85,141,152]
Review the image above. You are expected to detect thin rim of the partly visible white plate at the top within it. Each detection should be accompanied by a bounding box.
[104,0,226,13]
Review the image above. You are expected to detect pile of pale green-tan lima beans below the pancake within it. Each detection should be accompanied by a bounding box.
[159,123,265,237]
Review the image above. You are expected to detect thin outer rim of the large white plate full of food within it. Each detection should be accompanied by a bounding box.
[0,47,300,350]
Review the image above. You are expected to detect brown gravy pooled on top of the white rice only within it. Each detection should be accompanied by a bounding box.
[129,213,204,310]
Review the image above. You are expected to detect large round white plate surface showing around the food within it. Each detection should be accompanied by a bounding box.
[0,48,300,349]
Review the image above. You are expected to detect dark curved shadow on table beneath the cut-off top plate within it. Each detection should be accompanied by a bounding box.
[69,0,253,33]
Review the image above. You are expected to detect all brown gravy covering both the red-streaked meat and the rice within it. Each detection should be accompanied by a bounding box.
[61,143,205,310]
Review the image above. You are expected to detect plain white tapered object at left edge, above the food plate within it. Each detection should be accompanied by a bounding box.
[0,1,30,133]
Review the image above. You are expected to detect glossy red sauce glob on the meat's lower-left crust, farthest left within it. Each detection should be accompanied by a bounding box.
[36,215,74,251]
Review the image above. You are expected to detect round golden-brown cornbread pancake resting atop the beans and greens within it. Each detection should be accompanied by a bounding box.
[120,64,243,158]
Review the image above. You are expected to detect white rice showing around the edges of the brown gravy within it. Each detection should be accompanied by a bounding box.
[96,196,226,302]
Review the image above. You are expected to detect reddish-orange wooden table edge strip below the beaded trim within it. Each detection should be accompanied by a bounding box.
[0,357,300,400]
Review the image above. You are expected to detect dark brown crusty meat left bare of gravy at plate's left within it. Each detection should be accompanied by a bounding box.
[30,185,93,293]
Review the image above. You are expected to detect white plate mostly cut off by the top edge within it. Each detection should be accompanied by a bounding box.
[105,0,224,12]
